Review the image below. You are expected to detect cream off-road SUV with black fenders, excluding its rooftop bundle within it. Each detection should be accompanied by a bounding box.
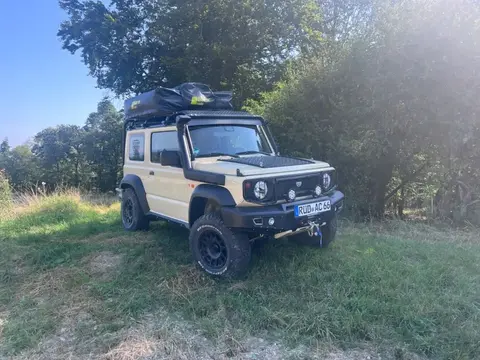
[120,84,344,277]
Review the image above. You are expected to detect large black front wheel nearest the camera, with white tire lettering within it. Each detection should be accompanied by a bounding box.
[189,213,252,278]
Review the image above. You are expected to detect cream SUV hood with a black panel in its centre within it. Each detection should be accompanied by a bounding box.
[192,156,330,176]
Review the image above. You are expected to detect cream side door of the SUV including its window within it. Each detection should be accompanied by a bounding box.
[146,128,192,223]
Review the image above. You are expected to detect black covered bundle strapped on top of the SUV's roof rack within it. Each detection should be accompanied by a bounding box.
[125,83,233,120]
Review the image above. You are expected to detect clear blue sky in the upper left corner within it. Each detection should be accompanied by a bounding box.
[0,0,121,145]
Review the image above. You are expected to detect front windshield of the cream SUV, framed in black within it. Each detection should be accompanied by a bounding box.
[189,125,272,157]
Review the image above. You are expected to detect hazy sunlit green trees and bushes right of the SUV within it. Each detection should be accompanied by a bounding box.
[247,1,480,219]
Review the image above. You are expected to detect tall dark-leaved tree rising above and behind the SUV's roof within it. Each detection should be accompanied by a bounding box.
[58,0,321,99]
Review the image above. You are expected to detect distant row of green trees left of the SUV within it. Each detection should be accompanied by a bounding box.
[0,99,122,192]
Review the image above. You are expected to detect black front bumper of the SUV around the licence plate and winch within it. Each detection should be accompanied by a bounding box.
[221,191,345,233]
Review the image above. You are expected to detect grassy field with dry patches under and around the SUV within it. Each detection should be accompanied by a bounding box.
[0,193,480,360]
